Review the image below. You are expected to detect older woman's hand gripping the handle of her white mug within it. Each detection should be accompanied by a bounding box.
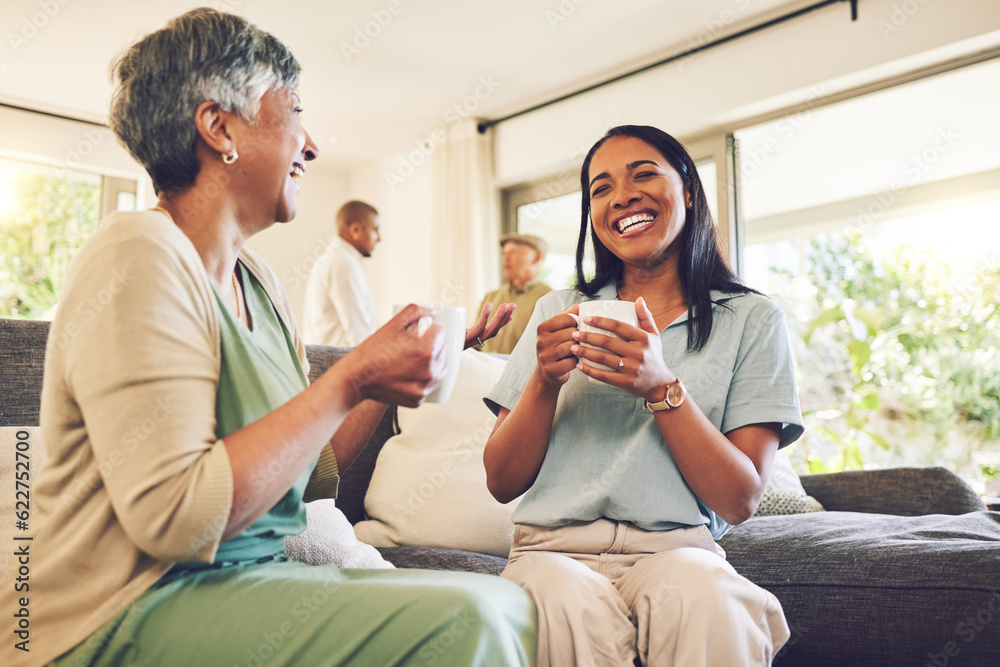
[348,304,445,408]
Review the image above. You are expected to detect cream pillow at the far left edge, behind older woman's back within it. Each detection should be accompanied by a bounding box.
[0,426,45,574]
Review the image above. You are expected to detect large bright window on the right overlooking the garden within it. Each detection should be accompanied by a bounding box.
[736,61,1000,484]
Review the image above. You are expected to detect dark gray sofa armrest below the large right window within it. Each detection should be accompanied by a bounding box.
[800,468,986,516]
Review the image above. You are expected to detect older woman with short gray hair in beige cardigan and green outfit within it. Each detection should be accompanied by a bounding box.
[0,9,535,667]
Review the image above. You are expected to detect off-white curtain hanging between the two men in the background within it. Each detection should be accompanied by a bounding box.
[431,118,500,322]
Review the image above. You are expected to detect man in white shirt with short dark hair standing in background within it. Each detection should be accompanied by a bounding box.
[303,200,382,346]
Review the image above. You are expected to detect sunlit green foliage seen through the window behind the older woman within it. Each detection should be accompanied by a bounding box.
[0,171,101,319]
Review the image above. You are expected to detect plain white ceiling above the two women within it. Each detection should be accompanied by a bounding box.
[0,0,804,169]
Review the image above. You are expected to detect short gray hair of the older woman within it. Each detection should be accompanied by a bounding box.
[111,7,300,195]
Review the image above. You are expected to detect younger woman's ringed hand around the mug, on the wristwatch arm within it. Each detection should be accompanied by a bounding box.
[570,297,676,403]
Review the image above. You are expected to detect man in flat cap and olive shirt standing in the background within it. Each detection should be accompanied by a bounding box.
[479,234,552,354]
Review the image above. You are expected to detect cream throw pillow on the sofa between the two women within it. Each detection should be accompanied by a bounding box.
[354,350,517,558]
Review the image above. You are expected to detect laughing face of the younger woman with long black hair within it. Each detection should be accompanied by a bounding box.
[588,136,690,268]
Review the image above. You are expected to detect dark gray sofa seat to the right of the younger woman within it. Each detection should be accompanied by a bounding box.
[720,511,1000,667]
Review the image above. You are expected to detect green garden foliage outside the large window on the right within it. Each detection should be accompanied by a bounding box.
[784,229,1000,478]
